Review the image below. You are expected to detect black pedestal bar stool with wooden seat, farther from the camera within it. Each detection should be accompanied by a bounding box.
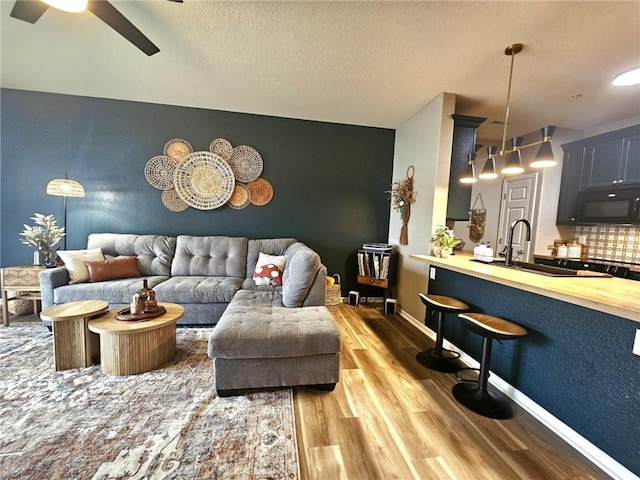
[416,293,469,373]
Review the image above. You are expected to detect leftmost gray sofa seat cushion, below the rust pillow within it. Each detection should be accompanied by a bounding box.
[53,276,168,305]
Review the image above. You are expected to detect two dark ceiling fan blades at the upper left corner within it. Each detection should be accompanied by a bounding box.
[9,0,182,56]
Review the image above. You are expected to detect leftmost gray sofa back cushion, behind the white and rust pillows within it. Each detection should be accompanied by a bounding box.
[87,233,176,277]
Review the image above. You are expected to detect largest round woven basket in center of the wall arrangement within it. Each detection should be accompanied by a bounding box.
[173,152,235,210]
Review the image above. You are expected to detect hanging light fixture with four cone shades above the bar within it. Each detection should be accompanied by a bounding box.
[460,43,556,183]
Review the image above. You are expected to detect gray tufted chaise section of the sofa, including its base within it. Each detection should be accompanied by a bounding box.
[209,290,341,397]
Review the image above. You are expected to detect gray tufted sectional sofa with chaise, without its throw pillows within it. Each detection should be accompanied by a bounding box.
[40,233,341,395]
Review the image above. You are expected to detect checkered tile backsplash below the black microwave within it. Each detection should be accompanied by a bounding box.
[571,225,640,264]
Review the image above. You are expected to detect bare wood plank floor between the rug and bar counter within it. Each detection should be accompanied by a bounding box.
[294,304,609,480]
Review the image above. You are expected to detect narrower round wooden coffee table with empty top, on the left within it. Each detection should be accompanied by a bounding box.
[40,300,109,371]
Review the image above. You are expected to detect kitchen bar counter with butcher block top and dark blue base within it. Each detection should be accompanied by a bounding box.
[410,253,640,479]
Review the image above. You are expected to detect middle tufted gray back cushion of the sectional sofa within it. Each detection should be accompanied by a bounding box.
[171,235,248,278]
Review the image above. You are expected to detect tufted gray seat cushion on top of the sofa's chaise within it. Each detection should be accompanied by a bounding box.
[209,290,341,359]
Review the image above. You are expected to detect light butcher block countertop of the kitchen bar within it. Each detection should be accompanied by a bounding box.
[409,252,640,323]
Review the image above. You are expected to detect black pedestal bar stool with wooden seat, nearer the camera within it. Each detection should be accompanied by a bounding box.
[453,313,527,419]
